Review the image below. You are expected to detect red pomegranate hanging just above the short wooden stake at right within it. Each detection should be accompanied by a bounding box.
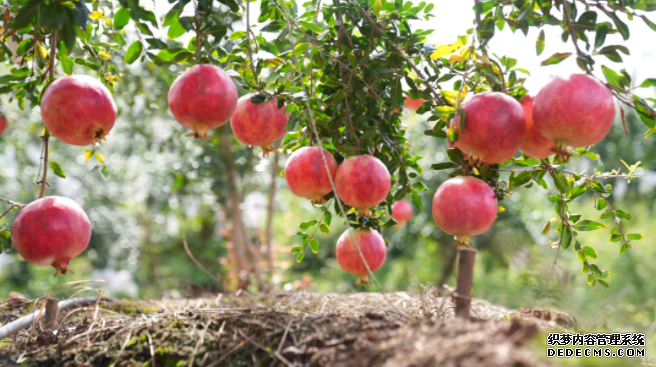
[433,176,497,246]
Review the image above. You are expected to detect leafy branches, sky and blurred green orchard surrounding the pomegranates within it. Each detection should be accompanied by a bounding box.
[0,0,656,366]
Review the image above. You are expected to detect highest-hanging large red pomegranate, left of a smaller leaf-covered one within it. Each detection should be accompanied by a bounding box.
[168,64,239,138]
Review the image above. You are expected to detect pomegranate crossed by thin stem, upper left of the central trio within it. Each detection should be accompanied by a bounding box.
[285,147,337,204]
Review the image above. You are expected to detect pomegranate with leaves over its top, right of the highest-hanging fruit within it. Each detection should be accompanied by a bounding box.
[230,93,289,157]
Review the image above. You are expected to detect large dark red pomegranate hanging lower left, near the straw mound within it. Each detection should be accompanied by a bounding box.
[12,196,91,276]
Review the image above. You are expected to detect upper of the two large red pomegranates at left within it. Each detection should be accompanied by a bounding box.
[41,75,116,145]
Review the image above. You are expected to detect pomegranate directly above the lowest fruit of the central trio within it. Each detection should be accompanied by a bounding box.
[335,154,392,216]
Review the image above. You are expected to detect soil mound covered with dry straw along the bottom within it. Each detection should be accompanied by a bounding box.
[0,291,574,367]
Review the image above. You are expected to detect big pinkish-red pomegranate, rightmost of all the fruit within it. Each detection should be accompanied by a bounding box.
[533,74,615,149]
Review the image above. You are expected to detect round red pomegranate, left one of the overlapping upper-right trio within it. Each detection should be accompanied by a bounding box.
[452,92,526,164]
